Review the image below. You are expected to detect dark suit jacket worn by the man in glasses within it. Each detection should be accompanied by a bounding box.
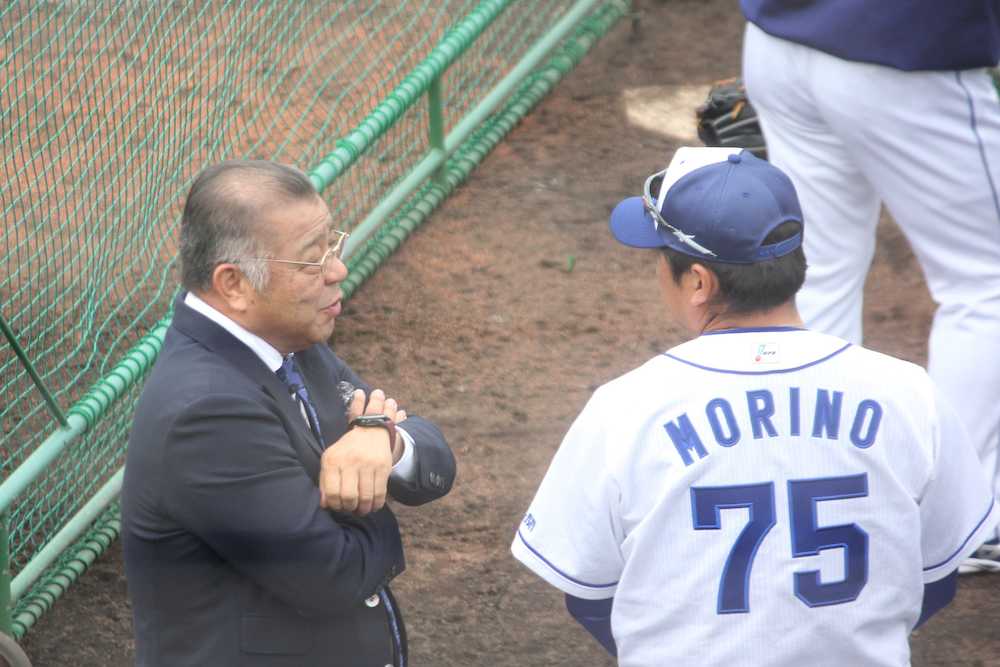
[122,295,455,667]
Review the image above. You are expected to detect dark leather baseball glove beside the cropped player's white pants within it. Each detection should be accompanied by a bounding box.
[695,79,767,159]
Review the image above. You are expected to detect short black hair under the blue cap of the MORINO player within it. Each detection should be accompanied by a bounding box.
[661,220,806,315]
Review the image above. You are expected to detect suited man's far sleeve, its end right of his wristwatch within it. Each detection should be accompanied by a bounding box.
[337,358,456,505]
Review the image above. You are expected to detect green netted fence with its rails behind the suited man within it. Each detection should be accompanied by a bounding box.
[0,0,629,637]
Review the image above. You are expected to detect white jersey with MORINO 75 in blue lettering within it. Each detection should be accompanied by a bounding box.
[512,327,998,667]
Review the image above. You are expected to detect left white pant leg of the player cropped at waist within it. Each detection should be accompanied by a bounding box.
[743,23,880,344]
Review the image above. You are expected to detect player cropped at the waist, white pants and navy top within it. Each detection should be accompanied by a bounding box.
[741,0,1000,571]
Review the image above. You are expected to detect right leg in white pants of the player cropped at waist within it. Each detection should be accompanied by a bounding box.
[840,68,1000,528]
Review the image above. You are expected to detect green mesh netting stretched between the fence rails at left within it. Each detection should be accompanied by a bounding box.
[0,0,616,620]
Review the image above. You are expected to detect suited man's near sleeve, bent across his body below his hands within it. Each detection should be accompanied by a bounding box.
[163,395,405,615]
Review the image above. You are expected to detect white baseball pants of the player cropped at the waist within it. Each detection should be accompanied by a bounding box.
[743,23,1000,532]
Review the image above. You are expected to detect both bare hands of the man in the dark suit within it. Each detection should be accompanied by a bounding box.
[319,389,406,516]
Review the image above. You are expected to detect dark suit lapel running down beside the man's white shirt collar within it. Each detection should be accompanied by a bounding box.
[172,292,323,462]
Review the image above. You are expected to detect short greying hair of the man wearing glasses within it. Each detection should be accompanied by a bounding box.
[180,160,317,292]
